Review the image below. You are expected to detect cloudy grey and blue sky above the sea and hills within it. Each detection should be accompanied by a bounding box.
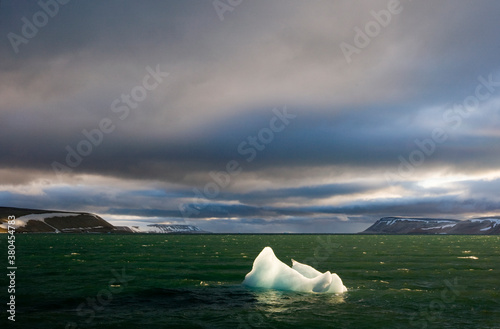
[0,0,500,233]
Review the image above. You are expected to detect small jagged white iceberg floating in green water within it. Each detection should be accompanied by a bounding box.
[243,247,347,294]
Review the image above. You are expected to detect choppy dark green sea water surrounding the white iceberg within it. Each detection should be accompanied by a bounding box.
[0,234,500,329]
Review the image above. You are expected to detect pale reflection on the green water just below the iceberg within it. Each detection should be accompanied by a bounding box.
[254,289,345,313]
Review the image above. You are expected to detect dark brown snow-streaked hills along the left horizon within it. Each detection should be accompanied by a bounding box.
[0,207,208,234]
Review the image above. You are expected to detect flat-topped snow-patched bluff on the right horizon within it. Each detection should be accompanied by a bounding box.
[361,217,500,234]
